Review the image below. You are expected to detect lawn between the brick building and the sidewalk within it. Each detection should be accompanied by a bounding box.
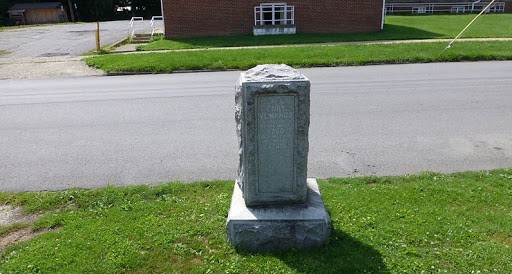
[139,14,512,50]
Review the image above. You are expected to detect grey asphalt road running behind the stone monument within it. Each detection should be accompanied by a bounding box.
[0,62,512,191]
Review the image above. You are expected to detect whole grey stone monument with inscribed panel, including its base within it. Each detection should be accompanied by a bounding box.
[227,65,331,251]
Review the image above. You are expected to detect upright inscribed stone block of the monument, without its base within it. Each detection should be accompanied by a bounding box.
[235,65,310,206]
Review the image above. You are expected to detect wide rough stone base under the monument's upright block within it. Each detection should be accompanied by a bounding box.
[227,178,331,251]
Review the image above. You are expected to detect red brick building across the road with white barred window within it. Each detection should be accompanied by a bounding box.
[162,0,384,38]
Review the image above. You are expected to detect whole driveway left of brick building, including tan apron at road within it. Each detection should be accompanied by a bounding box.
[0,21,129,80]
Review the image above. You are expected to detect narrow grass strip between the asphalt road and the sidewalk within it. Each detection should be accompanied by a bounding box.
[86,41,512,73]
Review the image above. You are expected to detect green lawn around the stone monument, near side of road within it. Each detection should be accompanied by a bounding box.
[0,169,512,273]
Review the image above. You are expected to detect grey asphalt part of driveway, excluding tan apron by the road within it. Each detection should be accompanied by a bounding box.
[0,21,129,58]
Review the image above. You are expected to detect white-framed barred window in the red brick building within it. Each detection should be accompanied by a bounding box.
[254,3,295,26]
